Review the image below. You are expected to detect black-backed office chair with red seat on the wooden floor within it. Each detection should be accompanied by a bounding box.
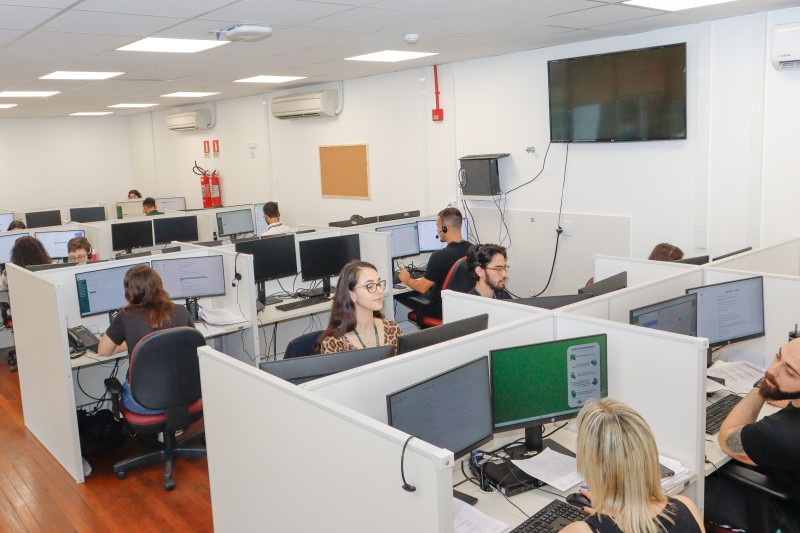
[114,327,206,490]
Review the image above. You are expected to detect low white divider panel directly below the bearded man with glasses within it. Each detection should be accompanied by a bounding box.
[442,291,551,328]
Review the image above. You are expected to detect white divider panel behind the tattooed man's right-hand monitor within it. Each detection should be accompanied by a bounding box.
[703,267,800,368]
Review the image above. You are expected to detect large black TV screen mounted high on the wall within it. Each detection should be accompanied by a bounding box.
[547,43,686,142]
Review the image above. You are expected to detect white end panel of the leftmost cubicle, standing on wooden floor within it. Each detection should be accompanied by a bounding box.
[6,264,83,483]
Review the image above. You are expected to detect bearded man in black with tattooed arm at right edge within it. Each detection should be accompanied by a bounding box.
[705,339,800,533]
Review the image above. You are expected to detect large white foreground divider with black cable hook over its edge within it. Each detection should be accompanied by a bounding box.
[199,348,453,532]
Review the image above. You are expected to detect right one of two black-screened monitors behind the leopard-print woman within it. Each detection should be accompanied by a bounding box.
[300,235,361,296]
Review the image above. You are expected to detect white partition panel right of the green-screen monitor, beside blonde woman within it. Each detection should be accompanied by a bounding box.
[555,312,708,509]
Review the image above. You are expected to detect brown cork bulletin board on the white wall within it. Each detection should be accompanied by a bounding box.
[319,144,369,199]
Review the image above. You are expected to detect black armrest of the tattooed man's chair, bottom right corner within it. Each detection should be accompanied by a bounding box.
[719,461,800,533]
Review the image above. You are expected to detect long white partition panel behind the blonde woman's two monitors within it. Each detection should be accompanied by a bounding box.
[303,314,553,422]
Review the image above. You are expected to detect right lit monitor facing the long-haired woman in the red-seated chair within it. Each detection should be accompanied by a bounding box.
[150,255,225,320]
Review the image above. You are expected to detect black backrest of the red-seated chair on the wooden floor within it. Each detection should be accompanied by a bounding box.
[128,327,206,409]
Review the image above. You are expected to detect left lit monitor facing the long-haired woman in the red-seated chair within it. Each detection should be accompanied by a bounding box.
[75,262,150,317]
